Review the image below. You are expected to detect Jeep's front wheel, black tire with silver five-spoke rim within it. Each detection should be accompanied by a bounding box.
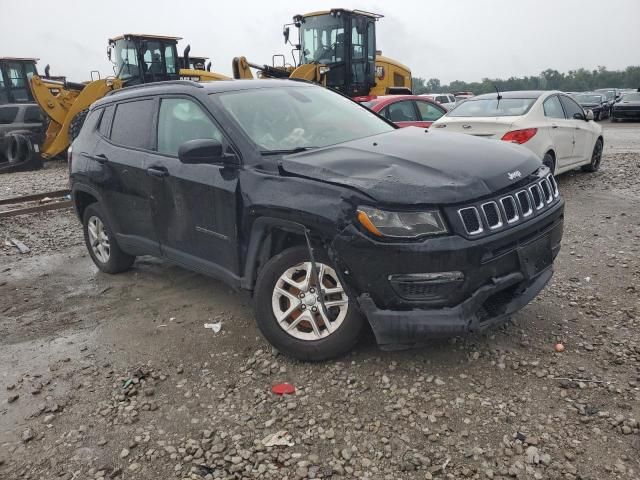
[255,246,364,361]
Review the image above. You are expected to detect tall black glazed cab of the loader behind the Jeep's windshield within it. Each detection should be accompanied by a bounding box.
[290,8,382,97]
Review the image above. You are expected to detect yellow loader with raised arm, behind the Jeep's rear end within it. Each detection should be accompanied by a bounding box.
[31,33,229,159]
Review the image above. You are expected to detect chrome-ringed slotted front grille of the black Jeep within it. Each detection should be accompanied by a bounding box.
[457,170,560,235]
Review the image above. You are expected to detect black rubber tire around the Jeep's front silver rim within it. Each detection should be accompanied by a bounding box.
[254,245,364,361]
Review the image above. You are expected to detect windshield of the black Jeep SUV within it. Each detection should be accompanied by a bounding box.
[212,86,394,153]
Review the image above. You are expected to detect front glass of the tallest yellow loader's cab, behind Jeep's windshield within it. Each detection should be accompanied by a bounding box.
[300,15,345,65]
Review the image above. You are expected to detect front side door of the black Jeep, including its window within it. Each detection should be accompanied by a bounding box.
[149,96,239,280]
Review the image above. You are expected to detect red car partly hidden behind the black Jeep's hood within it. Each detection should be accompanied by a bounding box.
[360,95,447,128]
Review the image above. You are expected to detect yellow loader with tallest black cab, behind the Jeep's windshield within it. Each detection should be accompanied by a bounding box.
[233,8,411,97]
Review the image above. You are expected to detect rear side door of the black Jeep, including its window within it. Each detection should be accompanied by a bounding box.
[93,98,160,255]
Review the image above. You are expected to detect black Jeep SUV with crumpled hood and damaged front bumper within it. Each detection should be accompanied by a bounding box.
[70,80,564,360]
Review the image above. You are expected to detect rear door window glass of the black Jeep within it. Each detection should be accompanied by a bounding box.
[111,99,155,148]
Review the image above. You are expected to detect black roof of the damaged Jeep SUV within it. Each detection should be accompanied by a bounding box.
[94,79,314,106]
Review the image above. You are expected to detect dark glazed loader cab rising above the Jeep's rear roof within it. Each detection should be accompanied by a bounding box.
[107,33,180,85]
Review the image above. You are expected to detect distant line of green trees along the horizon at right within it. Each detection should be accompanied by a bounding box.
[412,66,640,95]
